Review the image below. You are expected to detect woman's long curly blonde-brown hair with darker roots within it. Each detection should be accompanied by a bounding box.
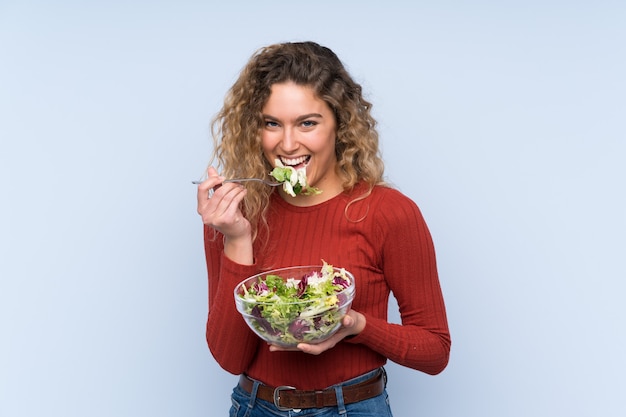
[211,42,384,238]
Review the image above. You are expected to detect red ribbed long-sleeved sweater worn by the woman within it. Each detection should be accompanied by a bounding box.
[205,184,450,390]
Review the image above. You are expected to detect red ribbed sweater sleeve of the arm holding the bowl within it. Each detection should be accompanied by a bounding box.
[349,191,451,375]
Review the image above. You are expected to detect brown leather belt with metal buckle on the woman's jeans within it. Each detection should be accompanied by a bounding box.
[239,368,386,410]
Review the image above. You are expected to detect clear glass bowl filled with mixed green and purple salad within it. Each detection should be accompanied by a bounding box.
[234,263,355,347]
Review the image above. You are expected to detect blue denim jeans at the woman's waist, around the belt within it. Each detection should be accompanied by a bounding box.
[229,370,393,417]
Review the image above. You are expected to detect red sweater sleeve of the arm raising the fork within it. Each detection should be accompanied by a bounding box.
[204,226,260,375]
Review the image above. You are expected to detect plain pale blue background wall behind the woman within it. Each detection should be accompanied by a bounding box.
[0,0,626,417]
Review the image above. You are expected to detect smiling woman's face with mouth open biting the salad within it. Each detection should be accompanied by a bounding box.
[261,82,343,202]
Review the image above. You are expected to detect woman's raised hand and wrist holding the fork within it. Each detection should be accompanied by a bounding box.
[198,167,254,265]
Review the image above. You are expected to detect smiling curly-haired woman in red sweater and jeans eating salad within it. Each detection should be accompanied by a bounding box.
[198,42,450,417]
